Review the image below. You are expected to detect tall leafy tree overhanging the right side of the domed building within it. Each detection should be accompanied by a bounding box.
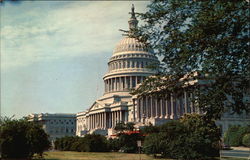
[133,0,250,119]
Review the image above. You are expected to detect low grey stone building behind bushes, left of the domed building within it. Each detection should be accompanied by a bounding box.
[28,113,76,141]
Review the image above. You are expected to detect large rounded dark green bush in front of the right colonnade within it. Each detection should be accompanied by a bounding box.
[143,114,220,159]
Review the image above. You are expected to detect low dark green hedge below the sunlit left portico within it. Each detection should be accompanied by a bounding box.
[55,134,108,152]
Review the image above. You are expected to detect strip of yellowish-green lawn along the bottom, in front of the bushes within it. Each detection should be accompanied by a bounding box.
[41,151,170,160]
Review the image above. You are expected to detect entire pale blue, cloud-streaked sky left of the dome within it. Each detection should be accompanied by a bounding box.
[0,1,150,118]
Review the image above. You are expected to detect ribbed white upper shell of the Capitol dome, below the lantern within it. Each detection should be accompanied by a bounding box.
[113,37,148,55]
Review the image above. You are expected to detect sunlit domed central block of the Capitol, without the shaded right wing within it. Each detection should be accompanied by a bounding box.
[76,6,159,136]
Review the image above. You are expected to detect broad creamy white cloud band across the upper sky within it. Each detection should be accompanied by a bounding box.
[1,1,149,69]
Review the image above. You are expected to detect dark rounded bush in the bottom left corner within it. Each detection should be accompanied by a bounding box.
[0,119,50,158]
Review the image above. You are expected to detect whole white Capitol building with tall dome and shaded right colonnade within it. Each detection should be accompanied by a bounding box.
[76,6,250,136]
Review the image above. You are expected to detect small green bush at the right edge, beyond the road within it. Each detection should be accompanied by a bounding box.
[224,126,250,146]
